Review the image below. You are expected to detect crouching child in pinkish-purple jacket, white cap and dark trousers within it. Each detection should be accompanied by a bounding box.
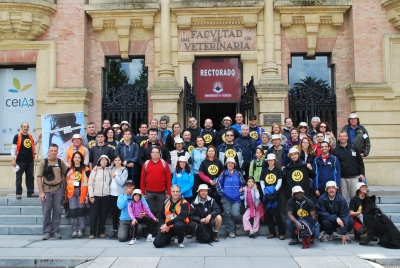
[128,189,158,245]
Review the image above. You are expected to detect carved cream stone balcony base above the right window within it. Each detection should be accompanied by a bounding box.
[275,4,350,56]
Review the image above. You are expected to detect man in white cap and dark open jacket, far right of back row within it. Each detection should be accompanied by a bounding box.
[342,113,371,157]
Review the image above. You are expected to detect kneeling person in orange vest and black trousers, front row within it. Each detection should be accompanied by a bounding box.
[153,184,189,248]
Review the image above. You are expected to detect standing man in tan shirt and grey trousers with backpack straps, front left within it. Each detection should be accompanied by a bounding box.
[37,144,67,240]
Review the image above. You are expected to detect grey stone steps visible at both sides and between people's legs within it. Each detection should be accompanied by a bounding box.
[0,195,400,236]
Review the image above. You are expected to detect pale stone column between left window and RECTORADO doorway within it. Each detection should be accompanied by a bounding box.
[147,0,182,122]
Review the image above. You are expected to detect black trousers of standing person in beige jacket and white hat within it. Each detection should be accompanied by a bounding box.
[90,195,110,235]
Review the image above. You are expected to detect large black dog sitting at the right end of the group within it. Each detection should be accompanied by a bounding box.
[360,195,400,249]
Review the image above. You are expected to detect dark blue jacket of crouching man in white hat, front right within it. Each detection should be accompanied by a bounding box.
[317,193,350,235]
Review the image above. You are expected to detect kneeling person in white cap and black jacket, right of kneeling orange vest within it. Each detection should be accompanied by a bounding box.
[190,184,222,242]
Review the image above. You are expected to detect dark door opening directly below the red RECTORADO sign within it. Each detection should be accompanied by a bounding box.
[199,103,237,130]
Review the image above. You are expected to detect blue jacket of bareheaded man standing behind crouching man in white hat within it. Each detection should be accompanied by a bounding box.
[313,154,340,191]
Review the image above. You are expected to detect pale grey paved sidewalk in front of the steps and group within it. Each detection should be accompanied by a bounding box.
[0,235,400,268]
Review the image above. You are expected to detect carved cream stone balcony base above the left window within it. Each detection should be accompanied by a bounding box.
[85,3,160,59]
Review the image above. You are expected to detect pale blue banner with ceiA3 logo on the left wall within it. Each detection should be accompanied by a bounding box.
[0,68,36,154]
